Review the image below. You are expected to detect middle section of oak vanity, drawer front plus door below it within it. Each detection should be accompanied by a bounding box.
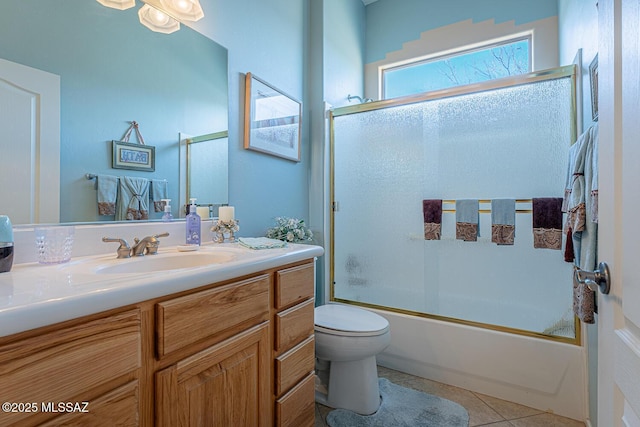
[155,274,272,427]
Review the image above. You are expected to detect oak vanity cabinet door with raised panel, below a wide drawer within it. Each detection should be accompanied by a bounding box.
[156,322,271,427]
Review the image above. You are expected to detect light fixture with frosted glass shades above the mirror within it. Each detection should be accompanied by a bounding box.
[96,0,204,34]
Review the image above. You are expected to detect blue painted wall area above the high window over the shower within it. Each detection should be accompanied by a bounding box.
[365,0,558,63]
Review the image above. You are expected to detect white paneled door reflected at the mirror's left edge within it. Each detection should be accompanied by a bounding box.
[0,59,60,224]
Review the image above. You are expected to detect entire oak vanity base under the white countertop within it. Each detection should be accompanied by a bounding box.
[0,258,315,427]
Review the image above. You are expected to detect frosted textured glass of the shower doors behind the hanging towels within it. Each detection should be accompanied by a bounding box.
[332,77,574,337]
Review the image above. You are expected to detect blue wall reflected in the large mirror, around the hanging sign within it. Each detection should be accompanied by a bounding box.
[0,0,228,224]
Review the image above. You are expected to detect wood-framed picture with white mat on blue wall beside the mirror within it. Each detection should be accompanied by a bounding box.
[244,73,302,162]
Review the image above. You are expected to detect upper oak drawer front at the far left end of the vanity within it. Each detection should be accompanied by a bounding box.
[0,309,141,426]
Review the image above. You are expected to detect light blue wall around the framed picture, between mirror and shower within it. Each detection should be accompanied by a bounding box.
[193,0,310,236]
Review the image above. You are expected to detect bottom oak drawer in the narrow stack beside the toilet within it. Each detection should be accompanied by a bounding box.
[276,374,316,427]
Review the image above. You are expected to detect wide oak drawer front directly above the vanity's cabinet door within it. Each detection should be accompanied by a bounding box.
[156,274,270,356]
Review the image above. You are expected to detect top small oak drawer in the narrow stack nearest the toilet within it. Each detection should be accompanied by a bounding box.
[275,263,315,310]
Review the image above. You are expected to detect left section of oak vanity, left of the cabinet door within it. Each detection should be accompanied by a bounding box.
[0,309,142,426]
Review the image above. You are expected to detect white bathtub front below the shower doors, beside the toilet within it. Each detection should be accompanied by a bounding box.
[370,309,588,421]
